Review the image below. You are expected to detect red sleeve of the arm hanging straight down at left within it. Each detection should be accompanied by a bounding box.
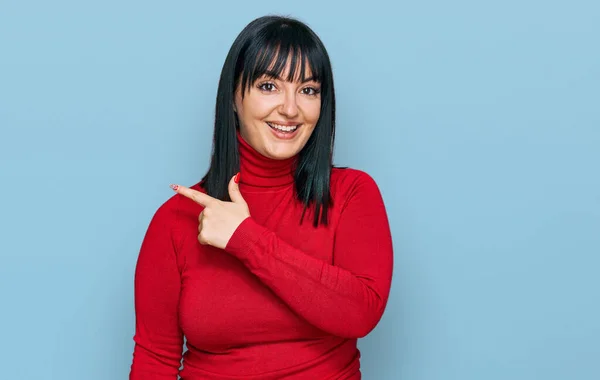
[129,200,183,380]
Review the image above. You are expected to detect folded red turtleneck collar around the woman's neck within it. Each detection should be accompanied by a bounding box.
[237,130,296,187]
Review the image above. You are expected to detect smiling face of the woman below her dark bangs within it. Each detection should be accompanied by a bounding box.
[235,62,321,160]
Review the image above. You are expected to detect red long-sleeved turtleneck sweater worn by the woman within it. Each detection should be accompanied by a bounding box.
[130,134,393,380]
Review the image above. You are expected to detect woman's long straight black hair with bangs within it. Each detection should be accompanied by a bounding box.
[202,16,335,227]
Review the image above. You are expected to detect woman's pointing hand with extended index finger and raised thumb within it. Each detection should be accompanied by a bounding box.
[171,173,250,249]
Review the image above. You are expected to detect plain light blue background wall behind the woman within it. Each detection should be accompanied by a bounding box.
[0,0,600,380]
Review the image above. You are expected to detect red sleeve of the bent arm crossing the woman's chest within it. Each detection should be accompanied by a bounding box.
[225,174,393,338]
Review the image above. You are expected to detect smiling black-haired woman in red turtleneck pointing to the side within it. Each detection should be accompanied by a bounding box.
[130,16,392,380]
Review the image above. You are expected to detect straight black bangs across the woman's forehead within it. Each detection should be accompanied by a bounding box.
[236,26,327,97]
